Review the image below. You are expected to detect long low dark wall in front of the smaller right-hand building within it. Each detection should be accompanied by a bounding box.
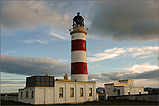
[108,94,159,101]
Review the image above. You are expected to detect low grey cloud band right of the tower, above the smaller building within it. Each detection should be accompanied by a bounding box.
[89,70,158,83]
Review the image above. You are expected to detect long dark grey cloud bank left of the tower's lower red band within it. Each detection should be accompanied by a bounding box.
[1,55,70,77]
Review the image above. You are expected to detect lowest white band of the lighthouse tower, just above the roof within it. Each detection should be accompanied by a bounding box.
[71,74,88,81]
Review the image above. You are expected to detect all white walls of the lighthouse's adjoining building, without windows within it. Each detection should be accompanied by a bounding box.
[18,81,98,104]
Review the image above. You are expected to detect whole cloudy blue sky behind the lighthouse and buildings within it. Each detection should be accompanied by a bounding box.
[1,0,159,93]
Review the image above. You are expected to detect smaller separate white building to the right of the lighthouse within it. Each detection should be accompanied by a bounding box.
[105,80,146,96]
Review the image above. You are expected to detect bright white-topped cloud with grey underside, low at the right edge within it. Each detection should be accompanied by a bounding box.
[101,63,159,80]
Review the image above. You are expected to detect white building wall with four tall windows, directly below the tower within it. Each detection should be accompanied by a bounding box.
[55,82,96,103]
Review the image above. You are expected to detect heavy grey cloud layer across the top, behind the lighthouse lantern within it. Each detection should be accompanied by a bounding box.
[1,0,159,41]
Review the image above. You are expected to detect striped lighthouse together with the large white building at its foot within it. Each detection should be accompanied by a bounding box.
[18,13,98,104]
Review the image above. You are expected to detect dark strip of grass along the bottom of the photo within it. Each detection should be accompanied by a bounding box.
[1,100,158,106]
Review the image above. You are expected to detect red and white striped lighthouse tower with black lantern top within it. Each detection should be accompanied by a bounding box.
[70,13,88,81]
